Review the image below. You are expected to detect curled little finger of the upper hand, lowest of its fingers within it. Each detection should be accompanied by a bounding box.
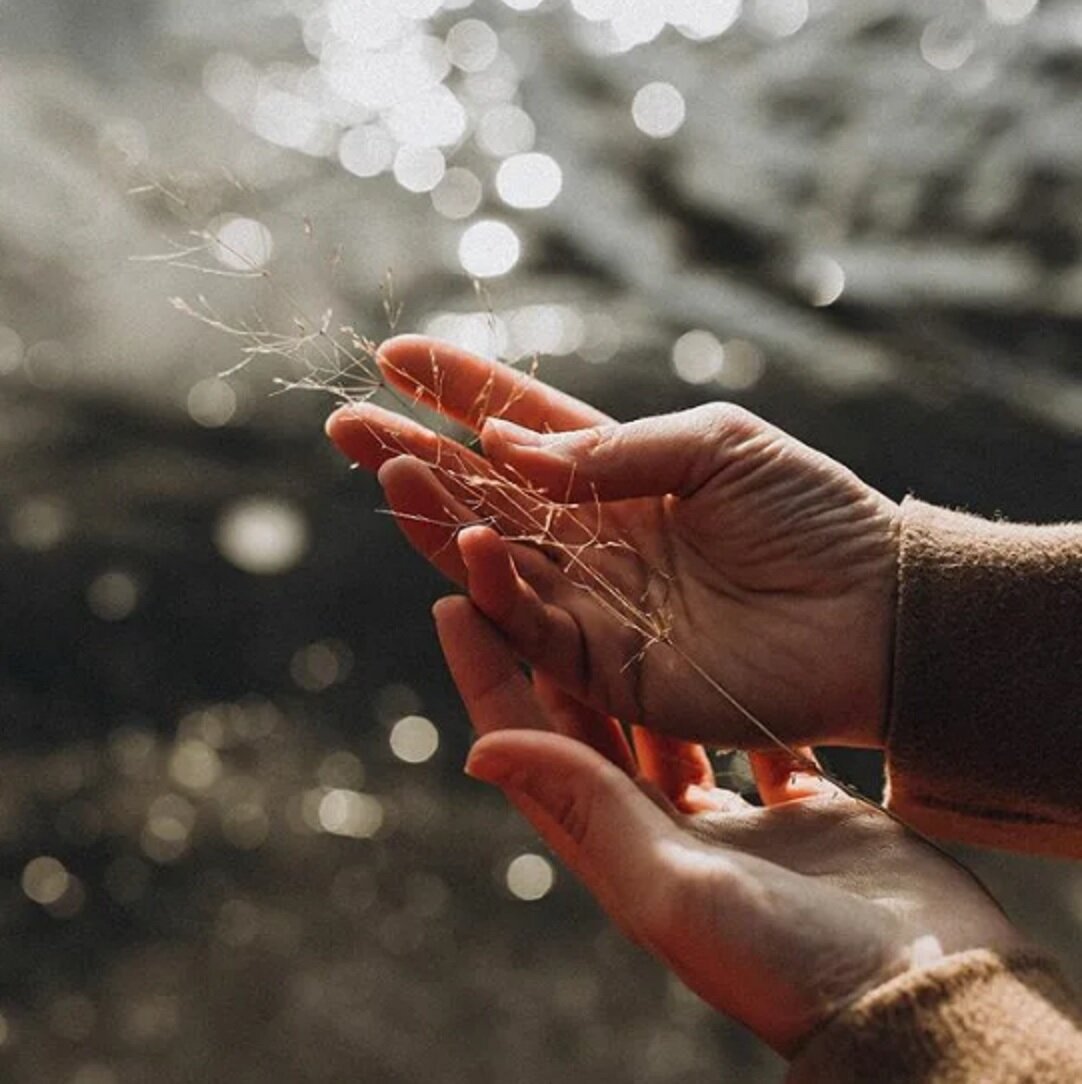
[458,527,583,689]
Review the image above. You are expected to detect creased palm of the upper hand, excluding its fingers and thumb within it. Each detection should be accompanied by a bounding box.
[483,410,896,745]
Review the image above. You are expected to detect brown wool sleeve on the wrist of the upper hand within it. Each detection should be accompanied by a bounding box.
[887,500,1082,858]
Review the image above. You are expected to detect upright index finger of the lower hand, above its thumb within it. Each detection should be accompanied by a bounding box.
[433,595,549,734]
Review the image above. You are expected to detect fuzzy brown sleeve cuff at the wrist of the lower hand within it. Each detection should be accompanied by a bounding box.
[786,949,1082,1084]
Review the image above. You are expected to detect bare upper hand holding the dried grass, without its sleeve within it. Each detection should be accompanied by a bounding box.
[329,337,898,747]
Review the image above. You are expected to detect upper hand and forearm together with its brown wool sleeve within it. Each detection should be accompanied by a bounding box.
[330,337,1082,855]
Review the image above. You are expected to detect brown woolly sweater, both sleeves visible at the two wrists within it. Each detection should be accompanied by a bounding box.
[787,499,1082,1084]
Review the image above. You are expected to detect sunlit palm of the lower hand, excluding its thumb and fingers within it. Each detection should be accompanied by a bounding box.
[645,791,1020,1054]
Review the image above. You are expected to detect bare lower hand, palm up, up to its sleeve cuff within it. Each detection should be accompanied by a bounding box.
[436,597,1021,1056]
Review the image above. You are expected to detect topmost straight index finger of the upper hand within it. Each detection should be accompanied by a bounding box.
[377,335,608,430]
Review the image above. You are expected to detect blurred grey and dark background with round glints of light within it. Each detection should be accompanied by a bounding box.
[0,0,1082,1084]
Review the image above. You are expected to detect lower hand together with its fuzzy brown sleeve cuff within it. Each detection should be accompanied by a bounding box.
[436,598,1082,1084]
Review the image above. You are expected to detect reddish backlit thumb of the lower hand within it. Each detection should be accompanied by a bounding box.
[466,731,685,946]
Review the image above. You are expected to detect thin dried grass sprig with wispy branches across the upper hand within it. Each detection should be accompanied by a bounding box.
[149,185,1006,906]
